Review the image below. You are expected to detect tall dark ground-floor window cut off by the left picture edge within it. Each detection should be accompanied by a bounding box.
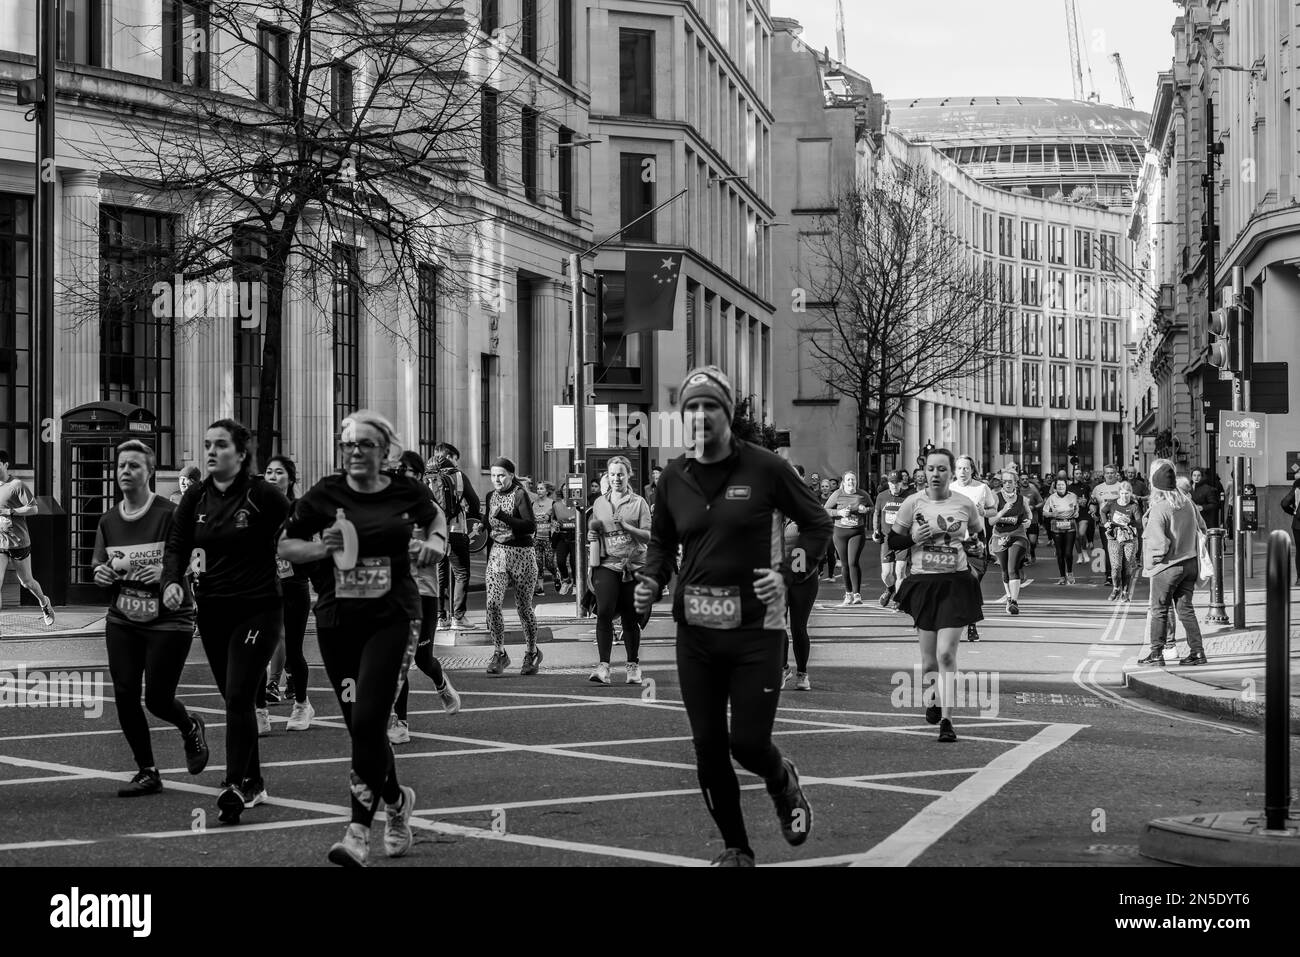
[0,192,33,468]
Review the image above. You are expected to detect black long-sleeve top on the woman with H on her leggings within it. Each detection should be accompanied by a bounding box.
[163,472,289,602]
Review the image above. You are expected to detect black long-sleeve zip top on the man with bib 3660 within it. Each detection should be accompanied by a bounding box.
[642,439,832,629]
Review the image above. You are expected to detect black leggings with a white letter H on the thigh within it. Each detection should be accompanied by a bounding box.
[198,598,285,787]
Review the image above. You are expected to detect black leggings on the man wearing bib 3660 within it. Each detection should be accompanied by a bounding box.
[677,624,787,854]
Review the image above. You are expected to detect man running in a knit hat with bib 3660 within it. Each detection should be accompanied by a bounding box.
[636,365,831,867]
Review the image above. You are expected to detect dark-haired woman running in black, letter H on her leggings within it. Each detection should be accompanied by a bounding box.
[163,419,289,824]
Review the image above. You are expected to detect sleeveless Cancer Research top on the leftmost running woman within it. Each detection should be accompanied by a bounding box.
[92,495,194,632]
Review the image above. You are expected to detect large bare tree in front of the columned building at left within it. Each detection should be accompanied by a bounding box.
[73,0,536,462]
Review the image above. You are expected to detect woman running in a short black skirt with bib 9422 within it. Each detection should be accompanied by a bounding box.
[889,449,982,742]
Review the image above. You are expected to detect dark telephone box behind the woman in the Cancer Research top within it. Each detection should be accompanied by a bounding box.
[60,400,157,603]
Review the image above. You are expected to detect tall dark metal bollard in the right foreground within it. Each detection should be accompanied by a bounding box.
[1264,531,1291,831]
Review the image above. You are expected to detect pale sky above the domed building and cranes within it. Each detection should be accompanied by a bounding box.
[771,0,1179,113]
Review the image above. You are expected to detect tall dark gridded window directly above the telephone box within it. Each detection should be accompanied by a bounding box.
[99,205,176,468]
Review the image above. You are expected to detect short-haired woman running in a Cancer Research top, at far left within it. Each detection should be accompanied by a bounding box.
[94,439,208,797]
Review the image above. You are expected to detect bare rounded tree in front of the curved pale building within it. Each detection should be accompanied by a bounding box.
[798,164,1008,475]
